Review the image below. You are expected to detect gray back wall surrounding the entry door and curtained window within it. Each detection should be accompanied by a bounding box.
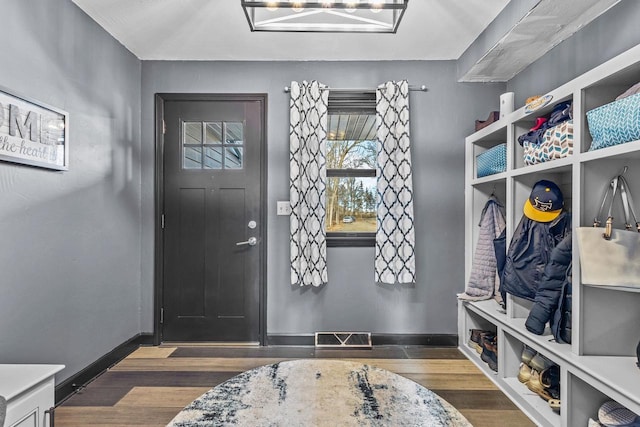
[142,61,505,334]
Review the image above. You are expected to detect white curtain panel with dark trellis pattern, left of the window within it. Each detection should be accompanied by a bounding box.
[289,81,329,286]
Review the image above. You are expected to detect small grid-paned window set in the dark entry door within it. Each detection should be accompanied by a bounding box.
[182,122,244,169]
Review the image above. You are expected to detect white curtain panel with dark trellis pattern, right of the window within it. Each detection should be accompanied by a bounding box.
[375,80,416,284]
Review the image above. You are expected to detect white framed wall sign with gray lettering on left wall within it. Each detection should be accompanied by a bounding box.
[0,88,69,170]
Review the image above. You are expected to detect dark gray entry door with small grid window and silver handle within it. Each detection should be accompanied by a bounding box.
[162,99,265,342]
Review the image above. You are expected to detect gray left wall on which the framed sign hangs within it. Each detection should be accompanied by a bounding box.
[0,0,141,380]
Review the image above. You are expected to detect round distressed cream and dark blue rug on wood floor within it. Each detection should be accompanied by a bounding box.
[168,359,471,427]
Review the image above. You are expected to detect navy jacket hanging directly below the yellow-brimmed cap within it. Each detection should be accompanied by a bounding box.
[500,212,571,301]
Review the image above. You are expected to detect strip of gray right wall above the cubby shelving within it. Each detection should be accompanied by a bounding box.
[507,0,640,108]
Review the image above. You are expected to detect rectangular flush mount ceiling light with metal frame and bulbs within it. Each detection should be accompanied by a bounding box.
[241,0,409,33]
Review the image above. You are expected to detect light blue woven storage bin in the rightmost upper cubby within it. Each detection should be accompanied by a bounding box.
[587,94,640,151]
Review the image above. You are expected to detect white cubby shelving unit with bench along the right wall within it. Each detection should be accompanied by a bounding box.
[458,45,640,427]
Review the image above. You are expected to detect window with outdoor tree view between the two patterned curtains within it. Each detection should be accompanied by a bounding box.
[326,91,378,246]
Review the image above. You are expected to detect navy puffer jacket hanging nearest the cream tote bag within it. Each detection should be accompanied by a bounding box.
[525,233,571,342]
